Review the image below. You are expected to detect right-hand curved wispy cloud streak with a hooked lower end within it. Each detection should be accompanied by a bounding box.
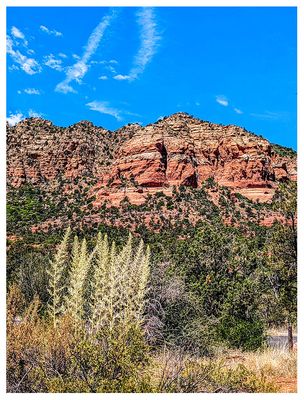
[113,7,161,81]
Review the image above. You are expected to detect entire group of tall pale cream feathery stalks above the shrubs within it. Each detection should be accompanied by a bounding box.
[48,229,150,332]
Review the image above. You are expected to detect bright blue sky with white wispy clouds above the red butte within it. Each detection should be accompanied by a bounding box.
[7,7,297,148]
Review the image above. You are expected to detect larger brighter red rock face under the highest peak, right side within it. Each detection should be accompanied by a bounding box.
[96,113,296,204]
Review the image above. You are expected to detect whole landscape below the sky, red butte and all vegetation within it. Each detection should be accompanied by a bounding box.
[7,113,297,393]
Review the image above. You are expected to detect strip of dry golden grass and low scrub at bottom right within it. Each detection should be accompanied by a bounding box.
[149,348,297,393]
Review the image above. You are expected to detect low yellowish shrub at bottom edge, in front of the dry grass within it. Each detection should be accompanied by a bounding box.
[152,350,277,393]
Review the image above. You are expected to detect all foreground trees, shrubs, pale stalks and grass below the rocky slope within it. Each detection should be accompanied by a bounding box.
[7,184,297,392]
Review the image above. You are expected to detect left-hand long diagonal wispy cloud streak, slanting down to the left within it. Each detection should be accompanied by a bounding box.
[55,14,114,93]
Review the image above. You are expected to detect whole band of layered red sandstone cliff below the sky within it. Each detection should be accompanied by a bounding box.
[7,113,297,208]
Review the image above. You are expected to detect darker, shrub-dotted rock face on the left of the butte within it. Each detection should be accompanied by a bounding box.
[7,118,137,187]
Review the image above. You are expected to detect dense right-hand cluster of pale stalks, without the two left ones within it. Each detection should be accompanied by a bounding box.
[90,231,150,330]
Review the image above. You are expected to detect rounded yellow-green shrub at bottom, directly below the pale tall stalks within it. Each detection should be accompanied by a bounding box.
[65,326,149,392]
